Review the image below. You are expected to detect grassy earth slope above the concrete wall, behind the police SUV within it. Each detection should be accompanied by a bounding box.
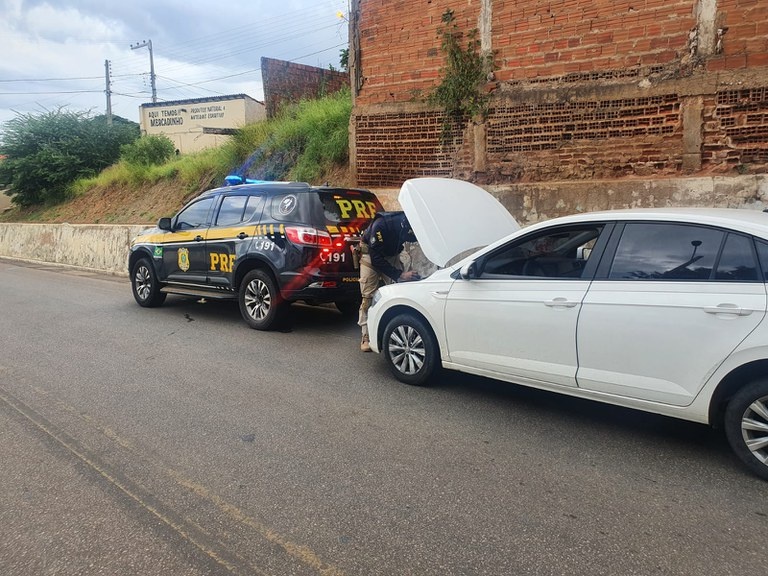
[0,92,354,224]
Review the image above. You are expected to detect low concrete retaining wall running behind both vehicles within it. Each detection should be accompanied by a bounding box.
[0,175,768,276]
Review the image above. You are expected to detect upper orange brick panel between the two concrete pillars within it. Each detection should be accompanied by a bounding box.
[493,0,695,82]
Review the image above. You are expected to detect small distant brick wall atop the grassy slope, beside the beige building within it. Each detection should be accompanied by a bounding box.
[261,58,349,118]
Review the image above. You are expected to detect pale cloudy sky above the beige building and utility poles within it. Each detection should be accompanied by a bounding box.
[0,0,348,130]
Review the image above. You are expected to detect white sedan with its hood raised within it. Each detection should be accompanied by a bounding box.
[368,178,768,479]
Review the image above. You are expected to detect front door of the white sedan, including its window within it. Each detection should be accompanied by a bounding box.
[445,223,603,386]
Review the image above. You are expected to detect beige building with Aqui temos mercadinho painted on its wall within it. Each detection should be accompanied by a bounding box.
[139,94,267,154]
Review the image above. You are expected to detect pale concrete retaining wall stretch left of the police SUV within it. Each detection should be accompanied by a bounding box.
[0,224,150,276]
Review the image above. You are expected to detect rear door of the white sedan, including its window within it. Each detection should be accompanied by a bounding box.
[577,222,766,406]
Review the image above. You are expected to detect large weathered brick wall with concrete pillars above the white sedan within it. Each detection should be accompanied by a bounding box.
[352,0,768,187]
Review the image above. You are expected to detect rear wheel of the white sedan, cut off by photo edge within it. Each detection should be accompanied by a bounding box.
[725,380,768,480]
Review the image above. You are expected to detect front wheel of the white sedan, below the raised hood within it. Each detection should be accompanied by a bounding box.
[382,314,439,386]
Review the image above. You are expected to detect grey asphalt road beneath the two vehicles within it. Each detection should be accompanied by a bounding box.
[0,261,768,576]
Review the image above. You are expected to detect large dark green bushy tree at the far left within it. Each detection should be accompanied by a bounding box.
[0,108,139,207]
